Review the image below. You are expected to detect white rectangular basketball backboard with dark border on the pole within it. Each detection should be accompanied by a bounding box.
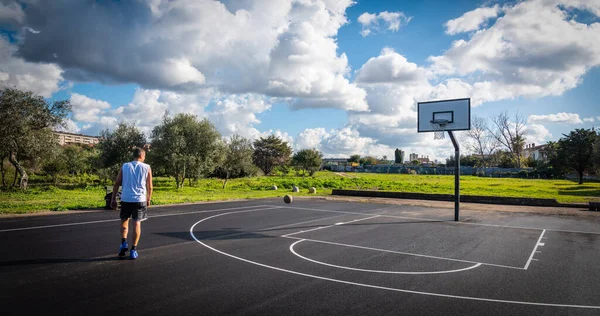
[417,98,471,133]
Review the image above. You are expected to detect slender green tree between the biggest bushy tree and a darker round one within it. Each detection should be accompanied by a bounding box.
[219,134,256,189]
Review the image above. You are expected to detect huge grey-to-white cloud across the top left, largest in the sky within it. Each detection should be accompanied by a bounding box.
[7,0,368,111]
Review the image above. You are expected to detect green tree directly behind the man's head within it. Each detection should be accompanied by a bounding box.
[98,123,146,170]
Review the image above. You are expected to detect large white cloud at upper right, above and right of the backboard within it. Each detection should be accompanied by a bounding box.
[429,0,600,100]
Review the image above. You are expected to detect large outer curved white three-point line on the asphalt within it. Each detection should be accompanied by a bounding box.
[190,213,600,309]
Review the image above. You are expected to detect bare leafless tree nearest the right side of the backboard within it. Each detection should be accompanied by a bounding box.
[466,116,498,167]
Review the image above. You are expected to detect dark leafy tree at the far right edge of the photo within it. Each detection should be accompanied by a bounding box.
[558,128,598,184]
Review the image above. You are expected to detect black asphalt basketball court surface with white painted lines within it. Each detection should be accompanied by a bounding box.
[0,199,600,315]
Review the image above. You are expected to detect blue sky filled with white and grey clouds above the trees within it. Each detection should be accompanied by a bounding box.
[0,0,600,159]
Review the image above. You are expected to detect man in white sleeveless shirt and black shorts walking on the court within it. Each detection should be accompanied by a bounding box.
[111,147,152,259]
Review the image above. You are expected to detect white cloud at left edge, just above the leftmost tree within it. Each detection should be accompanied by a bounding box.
[0,36,63,97]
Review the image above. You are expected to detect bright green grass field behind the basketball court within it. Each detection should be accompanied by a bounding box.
[0,172,600,214]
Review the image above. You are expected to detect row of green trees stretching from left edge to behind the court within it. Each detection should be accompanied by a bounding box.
[0,88,323,189]
